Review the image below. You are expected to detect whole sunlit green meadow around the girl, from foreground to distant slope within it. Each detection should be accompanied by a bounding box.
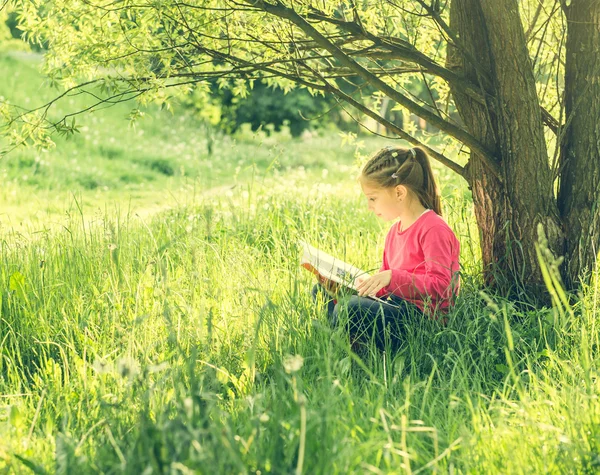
[0,55,600,475]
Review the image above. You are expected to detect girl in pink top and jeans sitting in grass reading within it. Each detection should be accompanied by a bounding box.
[313,147,460,347]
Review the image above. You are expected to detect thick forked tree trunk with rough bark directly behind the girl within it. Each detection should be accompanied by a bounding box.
[447,0,564,300]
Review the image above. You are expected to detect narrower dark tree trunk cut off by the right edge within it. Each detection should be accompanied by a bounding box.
[558,0,600,288]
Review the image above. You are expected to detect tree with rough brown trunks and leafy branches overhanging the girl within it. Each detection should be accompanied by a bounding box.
[4,0,600,300]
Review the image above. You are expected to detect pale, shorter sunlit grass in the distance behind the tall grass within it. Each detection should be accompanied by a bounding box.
[0,53,377,232]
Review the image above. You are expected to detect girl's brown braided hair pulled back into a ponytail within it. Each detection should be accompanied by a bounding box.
[360,147,442,216]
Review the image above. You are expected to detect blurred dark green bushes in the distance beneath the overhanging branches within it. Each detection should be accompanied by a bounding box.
[0,11,440,137]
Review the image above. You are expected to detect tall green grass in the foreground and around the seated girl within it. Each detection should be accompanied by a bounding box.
[0,165,600,473]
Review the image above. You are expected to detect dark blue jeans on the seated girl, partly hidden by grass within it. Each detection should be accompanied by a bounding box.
[312,284,423,349]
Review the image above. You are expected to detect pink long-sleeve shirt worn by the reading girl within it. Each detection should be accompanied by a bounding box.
[377,210,460,316]
